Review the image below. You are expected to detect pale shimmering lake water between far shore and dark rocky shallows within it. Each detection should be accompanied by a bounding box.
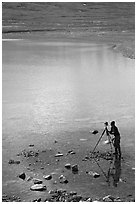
[2,40,135,199]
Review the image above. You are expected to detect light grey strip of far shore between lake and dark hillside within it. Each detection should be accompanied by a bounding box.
[2,29,135,59]
